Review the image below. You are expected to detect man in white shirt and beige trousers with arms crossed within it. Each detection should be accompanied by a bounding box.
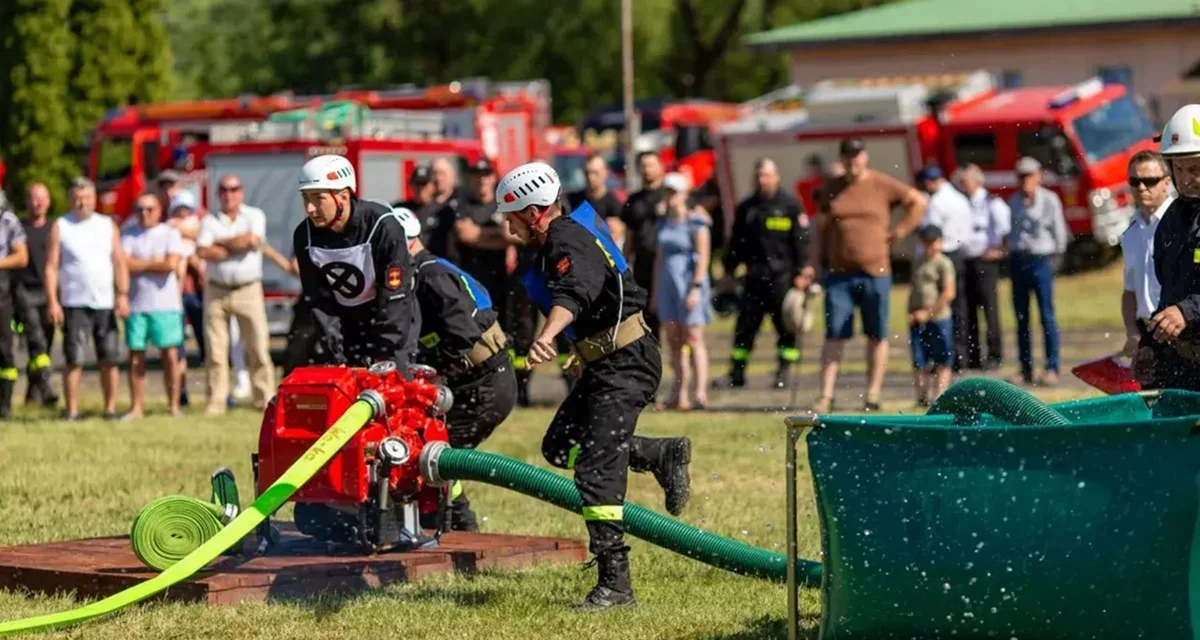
[196,175,275,415]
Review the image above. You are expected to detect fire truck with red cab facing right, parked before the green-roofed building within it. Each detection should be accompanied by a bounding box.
[718,71,1157,262]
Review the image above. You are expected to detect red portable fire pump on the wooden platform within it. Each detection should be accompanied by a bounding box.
[252,361,454,552]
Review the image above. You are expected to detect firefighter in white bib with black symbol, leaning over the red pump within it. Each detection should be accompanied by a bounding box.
[292,155,419,375]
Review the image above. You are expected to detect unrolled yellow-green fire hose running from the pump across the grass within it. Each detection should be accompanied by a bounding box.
[0,391,383,636]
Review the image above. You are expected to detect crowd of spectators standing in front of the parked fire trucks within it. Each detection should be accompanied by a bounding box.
[0,138,1171,420]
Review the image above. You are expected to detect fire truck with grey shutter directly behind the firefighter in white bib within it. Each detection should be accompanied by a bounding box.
[190,108,485,336]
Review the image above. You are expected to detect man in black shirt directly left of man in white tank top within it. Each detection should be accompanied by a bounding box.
[13,183,59,407]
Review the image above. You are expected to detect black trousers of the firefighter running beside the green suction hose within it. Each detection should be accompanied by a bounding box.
[541,335,662,555]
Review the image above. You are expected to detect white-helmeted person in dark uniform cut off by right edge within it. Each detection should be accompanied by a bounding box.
[1134,104,1200,391]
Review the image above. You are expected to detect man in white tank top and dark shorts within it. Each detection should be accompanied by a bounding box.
[46,178,130,420]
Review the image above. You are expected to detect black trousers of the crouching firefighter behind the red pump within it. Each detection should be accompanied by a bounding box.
[446,353,517,449]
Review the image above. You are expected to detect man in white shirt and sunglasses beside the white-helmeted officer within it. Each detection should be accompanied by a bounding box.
[1121,151,1175,358]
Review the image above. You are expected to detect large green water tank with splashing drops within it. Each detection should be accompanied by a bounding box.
[808,393,1200,640]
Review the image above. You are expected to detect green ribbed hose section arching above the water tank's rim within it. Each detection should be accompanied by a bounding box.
[929,378,1070,426]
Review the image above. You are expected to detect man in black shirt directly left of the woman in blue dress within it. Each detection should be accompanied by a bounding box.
[620,151,665,335]
